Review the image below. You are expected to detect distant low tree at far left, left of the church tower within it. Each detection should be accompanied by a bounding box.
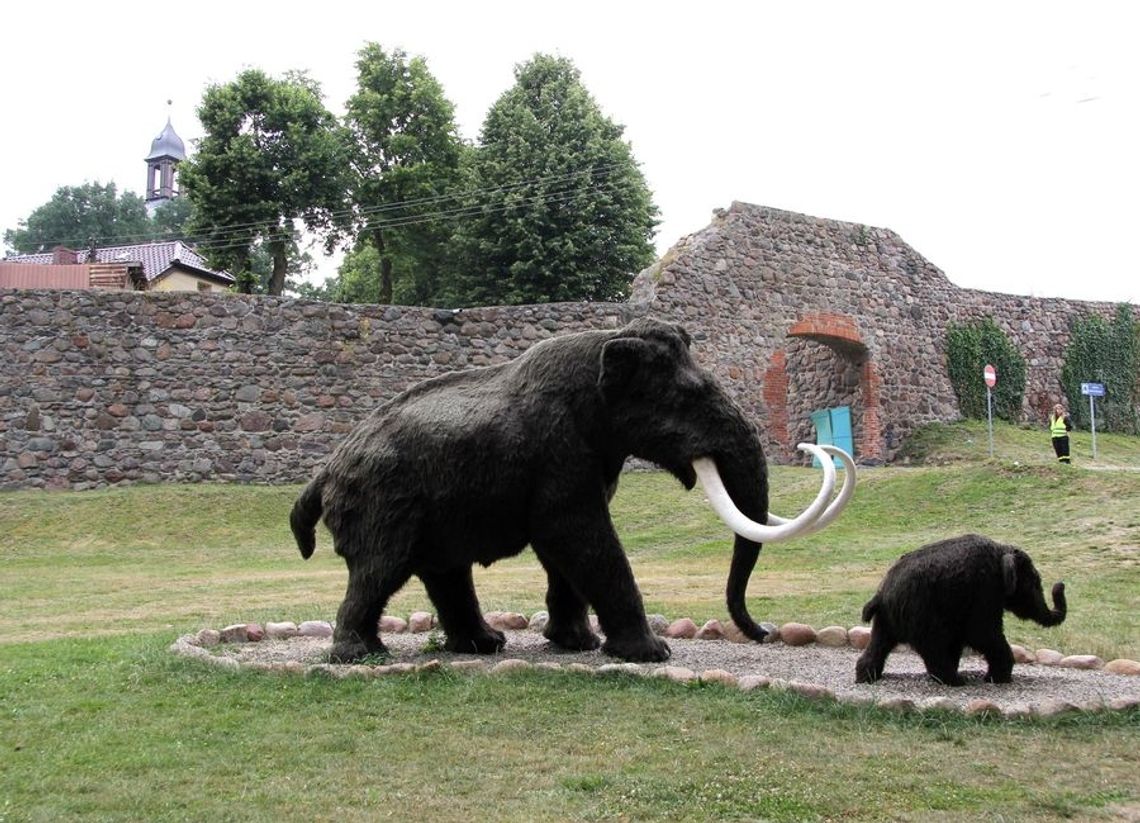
[3,182,153,254]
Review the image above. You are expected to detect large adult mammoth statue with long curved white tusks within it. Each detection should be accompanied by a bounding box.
[290,319,855,662]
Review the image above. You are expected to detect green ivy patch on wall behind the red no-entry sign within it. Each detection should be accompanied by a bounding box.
[946,317,1025,423]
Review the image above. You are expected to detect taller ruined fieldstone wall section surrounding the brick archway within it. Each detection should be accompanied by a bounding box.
[633,203,1114,458]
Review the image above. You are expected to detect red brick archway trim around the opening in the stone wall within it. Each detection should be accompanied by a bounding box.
[764,312,882,461]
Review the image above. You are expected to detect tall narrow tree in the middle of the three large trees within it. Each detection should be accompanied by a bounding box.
[341,43,464,303]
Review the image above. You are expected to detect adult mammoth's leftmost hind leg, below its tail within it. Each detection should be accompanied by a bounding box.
[329,556,410,663]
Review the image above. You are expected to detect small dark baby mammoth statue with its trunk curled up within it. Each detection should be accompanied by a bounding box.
[855,535,1066,686]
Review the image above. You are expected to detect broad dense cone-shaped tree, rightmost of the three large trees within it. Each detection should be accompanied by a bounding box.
[450,55,658,305]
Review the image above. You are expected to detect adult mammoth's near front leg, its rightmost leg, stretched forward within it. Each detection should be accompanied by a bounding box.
[531,495,669,662]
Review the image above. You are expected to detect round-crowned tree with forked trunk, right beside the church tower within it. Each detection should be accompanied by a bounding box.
[179,68,347,294]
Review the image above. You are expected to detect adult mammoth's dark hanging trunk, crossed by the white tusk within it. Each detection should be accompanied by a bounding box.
[716,448,768,642]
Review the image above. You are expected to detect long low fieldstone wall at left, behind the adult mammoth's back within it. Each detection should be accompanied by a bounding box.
[0,291,640,489]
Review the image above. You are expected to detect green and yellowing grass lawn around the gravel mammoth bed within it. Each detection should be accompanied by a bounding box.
[0,424,1140,821]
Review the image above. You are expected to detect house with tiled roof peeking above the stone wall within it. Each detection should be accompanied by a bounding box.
[0,241,234,292]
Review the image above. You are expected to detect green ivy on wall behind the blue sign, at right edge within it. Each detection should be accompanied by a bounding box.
[1061,303,1140,434]
